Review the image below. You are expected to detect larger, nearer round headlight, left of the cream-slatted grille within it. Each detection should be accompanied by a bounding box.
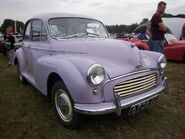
[87,64,105,86]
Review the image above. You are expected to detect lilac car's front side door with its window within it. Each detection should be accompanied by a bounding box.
[30,19,50,82]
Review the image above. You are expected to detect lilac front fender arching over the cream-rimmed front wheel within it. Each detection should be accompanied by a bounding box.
[34,56,105,103]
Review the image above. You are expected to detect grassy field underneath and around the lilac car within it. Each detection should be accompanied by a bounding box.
[0,54,185,139]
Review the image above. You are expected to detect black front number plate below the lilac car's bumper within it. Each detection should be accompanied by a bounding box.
[128,96,158,116]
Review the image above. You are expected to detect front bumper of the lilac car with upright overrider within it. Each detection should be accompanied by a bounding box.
[74,77,167,116]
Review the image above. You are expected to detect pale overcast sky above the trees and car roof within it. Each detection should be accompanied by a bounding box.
[0,0,185,25]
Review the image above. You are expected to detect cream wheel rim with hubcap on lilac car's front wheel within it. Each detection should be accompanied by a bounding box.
[55,89,73,122]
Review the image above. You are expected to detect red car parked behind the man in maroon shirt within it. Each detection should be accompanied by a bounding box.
[116,26,185,62]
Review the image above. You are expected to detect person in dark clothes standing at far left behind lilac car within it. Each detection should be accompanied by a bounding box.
[4,26,15,66]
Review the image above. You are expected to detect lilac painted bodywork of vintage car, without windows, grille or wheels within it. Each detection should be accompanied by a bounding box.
[15,14,165,114]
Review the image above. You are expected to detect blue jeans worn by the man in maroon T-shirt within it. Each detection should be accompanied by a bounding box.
[148,39,165,53]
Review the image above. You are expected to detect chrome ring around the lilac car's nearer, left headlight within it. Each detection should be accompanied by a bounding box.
[86,64,105,86]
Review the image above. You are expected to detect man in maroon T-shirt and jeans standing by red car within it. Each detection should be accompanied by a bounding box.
[149,1,168,53]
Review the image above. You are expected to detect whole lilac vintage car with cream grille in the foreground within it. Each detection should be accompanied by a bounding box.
[15,13,166,128]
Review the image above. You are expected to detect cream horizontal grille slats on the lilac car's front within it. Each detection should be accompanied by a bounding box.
[114,73,157,97]
